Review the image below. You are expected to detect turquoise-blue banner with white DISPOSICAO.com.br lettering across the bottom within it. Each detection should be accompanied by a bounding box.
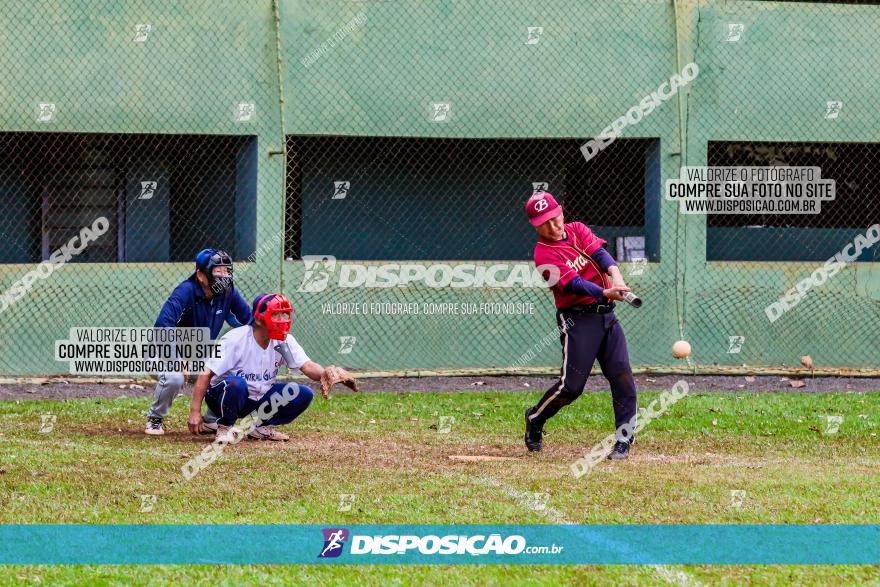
[0,524,880,565]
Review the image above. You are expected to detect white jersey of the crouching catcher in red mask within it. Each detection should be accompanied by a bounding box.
[206,326,310,400]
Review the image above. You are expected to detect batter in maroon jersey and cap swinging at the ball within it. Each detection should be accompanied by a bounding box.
[525,192,637,460]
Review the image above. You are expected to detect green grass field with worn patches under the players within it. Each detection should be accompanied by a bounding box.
[0,392,880,585]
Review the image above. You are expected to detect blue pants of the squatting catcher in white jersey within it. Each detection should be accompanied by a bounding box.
[205,377,314,426]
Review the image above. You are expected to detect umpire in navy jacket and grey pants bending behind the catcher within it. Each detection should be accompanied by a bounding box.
[144,249,251,436]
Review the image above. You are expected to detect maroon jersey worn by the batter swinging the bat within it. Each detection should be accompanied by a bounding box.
[535,222,608,308]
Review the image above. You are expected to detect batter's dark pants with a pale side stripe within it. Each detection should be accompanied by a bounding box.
[529,310,638,441]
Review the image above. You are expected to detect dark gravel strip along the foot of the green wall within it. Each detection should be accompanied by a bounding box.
[0,375,880,401]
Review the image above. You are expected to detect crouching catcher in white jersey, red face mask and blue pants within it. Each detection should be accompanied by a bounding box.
[188,293,358,444]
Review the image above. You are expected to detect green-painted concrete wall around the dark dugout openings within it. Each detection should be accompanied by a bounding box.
[0,0,880,374]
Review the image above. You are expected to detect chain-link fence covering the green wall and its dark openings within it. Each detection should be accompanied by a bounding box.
[0,0,880,374]
